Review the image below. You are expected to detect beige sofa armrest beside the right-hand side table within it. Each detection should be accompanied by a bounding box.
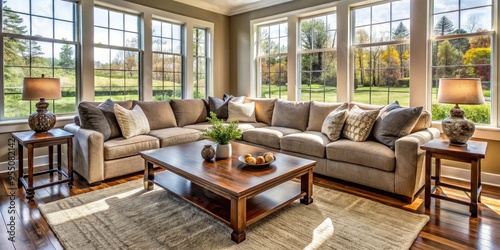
[394,128,440,198]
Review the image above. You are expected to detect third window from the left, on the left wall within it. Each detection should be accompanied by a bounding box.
[153,20,184,100]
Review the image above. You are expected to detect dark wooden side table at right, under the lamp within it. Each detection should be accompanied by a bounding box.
[420,139,488,217]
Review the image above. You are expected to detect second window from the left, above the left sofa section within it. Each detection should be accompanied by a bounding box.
[94,7,140,101]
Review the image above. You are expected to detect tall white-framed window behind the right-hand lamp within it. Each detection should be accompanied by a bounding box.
[431,0,493,124]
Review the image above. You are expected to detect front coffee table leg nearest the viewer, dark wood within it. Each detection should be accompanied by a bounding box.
[231,197,247,244]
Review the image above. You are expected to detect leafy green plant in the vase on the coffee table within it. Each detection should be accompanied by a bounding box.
[203,112,241,145]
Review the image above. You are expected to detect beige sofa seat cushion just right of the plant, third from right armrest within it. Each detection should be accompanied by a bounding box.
[243,127,302,149]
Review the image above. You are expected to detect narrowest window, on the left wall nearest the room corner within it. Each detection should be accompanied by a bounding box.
[193,28,208,98]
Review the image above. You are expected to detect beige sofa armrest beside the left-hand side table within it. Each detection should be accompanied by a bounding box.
[64,123,104,183]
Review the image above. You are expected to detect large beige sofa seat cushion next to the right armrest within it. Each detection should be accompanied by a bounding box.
[326,139,396,172]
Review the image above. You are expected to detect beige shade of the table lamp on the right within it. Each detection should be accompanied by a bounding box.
[437,78,484,104]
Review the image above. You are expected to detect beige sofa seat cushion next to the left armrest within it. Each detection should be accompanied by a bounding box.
[104,135,160,161]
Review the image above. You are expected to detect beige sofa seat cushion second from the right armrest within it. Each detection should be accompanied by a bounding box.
[281,131,331,158]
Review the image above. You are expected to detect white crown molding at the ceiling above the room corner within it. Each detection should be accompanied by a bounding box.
[174,0,292,16]
